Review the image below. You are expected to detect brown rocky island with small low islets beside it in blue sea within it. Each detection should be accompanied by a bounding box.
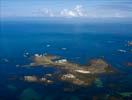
[24,54,114,86]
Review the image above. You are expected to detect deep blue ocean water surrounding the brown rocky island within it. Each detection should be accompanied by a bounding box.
[0,20,132,100]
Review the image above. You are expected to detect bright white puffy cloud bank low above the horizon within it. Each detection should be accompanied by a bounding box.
[36,5,87,18]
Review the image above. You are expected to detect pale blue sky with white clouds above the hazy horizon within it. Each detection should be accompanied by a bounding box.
[0,0,132,19]
